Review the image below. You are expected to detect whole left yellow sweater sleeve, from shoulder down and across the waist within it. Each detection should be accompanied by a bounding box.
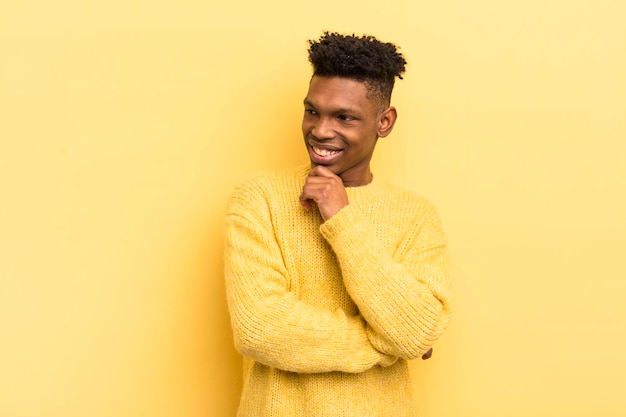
[224,181,397,373]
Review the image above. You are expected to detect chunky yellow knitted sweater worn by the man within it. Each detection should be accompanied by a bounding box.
[225,167,450,417]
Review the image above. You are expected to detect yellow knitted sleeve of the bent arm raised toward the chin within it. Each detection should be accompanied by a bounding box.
[321,200,450,359]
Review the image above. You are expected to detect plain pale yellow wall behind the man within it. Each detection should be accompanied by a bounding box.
[0,0,626,417]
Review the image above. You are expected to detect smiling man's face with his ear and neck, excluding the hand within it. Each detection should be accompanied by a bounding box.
[302,76,396,186]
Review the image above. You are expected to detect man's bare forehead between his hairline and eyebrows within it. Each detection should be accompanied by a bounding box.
[304,75,374,111]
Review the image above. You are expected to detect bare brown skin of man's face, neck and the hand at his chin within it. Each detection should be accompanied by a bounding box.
[300,76,397,221]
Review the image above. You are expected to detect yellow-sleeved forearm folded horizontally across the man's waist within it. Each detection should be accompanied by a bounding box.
[224,282,397,373]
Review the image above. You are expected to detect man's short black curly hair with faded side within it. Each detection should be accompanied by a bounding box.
[309,32,406,105]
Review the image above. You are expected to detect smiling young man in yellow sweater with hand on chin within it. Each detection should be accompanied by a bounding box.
[225,33,450,417]
